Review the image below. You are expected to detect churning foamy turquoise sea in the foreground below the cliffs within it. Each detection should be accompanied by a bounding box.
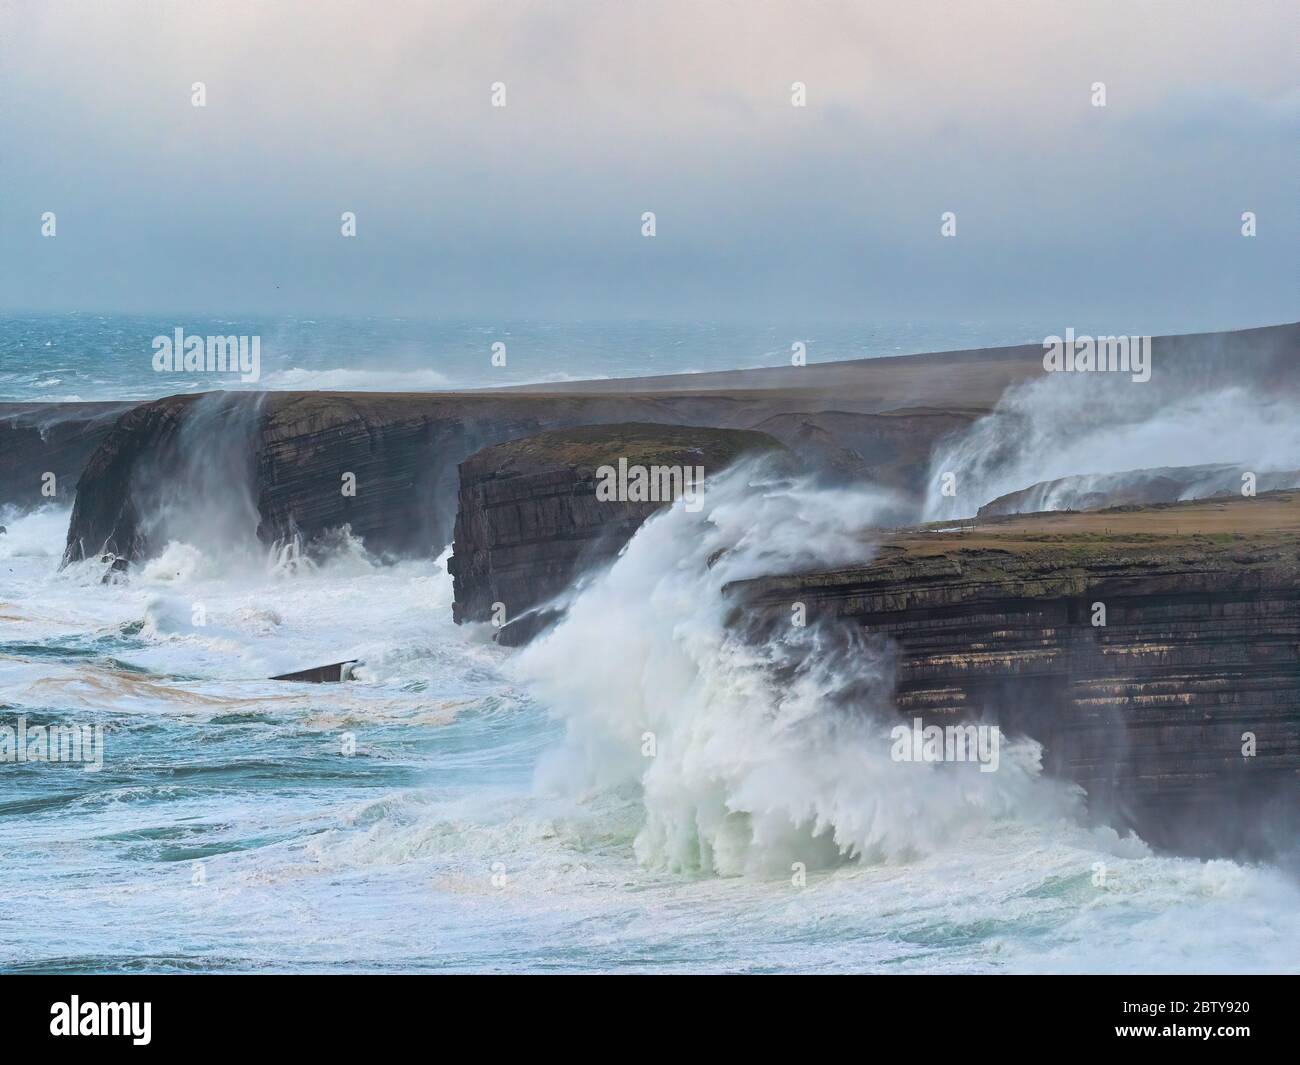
[0,496,1300,971]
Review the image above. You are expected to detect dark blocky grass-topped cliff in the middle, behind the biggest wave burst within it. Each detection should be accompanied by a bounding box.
[447,423,780,644]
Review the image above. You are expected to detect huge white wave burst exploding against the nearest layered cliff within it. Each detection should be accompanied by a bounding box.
[517,466,1067,875]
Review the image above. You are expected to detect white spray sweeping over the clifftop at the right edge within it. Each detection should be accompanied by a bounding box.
[924,371,1300,520]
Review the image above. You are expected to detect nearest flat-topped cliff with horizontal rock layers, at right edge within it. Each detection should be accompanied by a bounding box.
[733,493,1300,856]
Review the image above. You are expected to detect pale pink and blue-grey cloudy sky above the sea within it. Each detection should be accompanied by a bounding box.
[0,0,1300,333]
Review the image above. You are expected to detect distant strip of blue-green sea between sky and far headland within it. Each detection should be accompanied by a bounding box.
[0,313,1061,402]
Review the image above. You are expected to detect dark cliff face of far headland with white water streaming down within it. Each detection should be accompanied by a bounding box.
[58,393,970,560]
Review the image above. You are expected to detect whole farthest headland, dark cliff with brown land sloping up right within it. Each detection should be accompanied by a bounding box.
[55,325,1300,559]
